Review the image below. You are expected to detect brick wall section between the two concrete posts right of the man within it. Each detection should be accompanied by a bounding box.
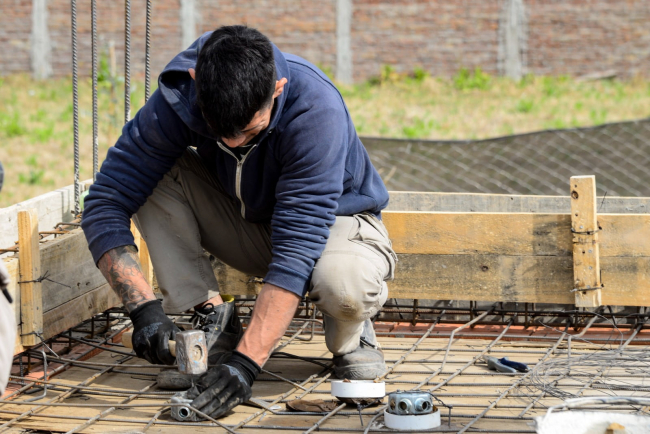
[352,0,501,79]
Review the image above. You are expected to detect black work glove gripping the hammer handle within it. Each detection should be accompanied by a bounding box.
[129,300,181,365]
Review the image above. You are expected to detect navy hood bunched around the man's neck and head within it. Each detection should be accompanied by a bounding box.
[158,32,291,139]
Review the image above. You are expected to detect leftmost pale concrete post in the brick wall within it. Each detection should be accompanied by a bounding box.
[30,0,52,80]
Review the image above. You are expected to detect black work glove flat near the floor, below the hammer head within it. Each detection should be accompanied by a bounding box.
[187,351,262,419]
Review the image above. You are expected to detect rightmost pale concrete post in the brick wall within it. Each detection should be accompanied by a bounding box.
[499,0,528,80]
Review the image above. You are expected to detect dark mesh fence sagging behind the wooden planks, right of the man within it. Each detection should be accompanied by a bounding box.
[362,118,650,197]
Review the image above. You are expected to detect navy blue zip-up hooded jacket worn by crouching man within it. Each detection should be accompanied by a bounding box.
[82,33,388,295]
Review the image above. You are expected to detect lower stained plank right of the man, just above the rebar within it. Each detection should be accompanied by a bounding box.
[388,254,650,306]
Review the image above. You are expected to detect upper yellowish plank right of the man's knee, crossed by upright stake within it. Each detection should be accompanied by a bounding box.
[382,211,650,257]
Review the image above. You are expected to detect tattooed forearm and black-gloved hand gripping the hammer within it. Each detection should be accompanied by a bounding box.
[97,246,180,365]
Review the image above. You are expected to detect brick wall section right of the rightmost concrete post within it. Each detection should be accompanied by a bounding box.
[526,0,650,77]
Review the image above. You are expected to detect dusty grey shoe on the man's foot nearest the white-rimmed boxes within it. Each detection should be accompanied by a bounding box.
[332,319,386,380]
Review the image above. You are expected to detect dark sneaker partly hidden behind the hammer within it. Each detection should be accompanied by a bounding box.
[158,296,244,390]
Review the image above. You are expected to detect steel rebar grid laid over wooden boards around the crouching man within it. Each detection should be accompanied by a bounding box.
[0,302,650,433]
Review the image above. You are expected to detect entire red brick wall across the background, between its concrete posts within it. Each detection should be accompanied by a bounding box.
[0,0,650,81]
